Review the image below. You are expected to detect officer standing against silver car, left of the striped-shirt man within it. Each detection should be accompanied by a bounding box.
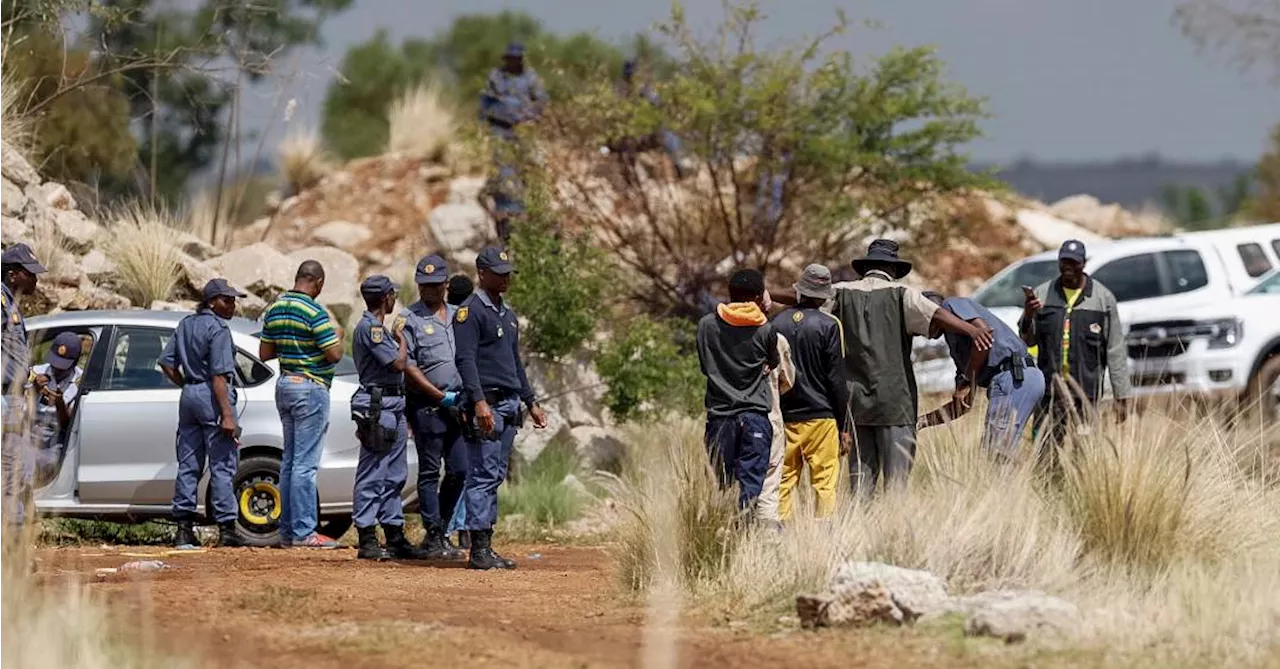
[160,279,244,549]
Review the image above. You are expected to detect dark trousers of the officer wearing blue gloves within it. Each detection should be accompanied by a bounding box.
[408,403,467,530]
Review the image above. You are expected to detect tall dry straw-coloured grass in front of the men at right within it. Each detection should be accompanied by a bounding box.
[616,404,1280,666]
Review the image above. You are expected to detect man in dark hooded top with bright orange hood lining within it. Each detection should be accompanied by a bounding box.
[698,269,781,512]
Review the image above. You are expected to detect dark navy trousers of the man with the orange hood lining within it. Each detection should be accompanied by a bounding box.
[705,412,773,509]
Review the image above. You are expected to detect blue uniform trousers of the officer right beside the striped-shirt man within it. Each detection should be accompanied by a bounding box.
[352,409,408,527]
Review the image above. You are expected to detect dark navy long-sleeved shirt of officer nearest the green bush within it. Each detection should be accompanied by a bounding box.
[453,288,534,407]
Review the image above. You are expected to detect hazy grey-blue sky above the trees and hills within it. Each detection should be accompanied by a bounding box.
[235,0,1280,161]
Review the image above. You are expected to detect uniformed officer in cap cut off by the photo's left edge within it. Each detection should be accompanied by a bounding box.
[0,242,46,524]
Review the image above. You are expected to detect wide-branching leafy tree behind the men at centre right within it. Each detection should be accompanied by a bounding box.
[529,4,992,317]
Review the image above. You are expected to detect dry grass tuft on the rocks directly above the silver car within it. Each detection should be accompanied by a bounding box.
[102,203,180,307]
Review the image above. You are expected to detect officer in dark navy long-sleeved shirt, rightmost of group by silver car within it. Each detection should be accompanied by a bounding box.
[453,247,547,569]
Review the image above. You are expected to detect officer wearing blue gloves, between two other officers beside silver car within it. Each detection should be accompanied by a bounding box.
[396,255,467,560]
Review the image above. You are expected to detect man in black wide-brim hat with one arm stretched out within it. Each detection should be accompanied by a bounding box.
[832,239,991,495]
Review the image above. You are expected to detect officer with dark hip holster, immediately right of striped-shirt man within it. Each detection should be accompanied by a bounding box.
[351,274,424,560]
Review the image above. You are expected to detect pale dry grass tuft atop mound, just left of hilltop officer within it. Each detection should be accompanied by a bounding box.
[387,81,458,162]
